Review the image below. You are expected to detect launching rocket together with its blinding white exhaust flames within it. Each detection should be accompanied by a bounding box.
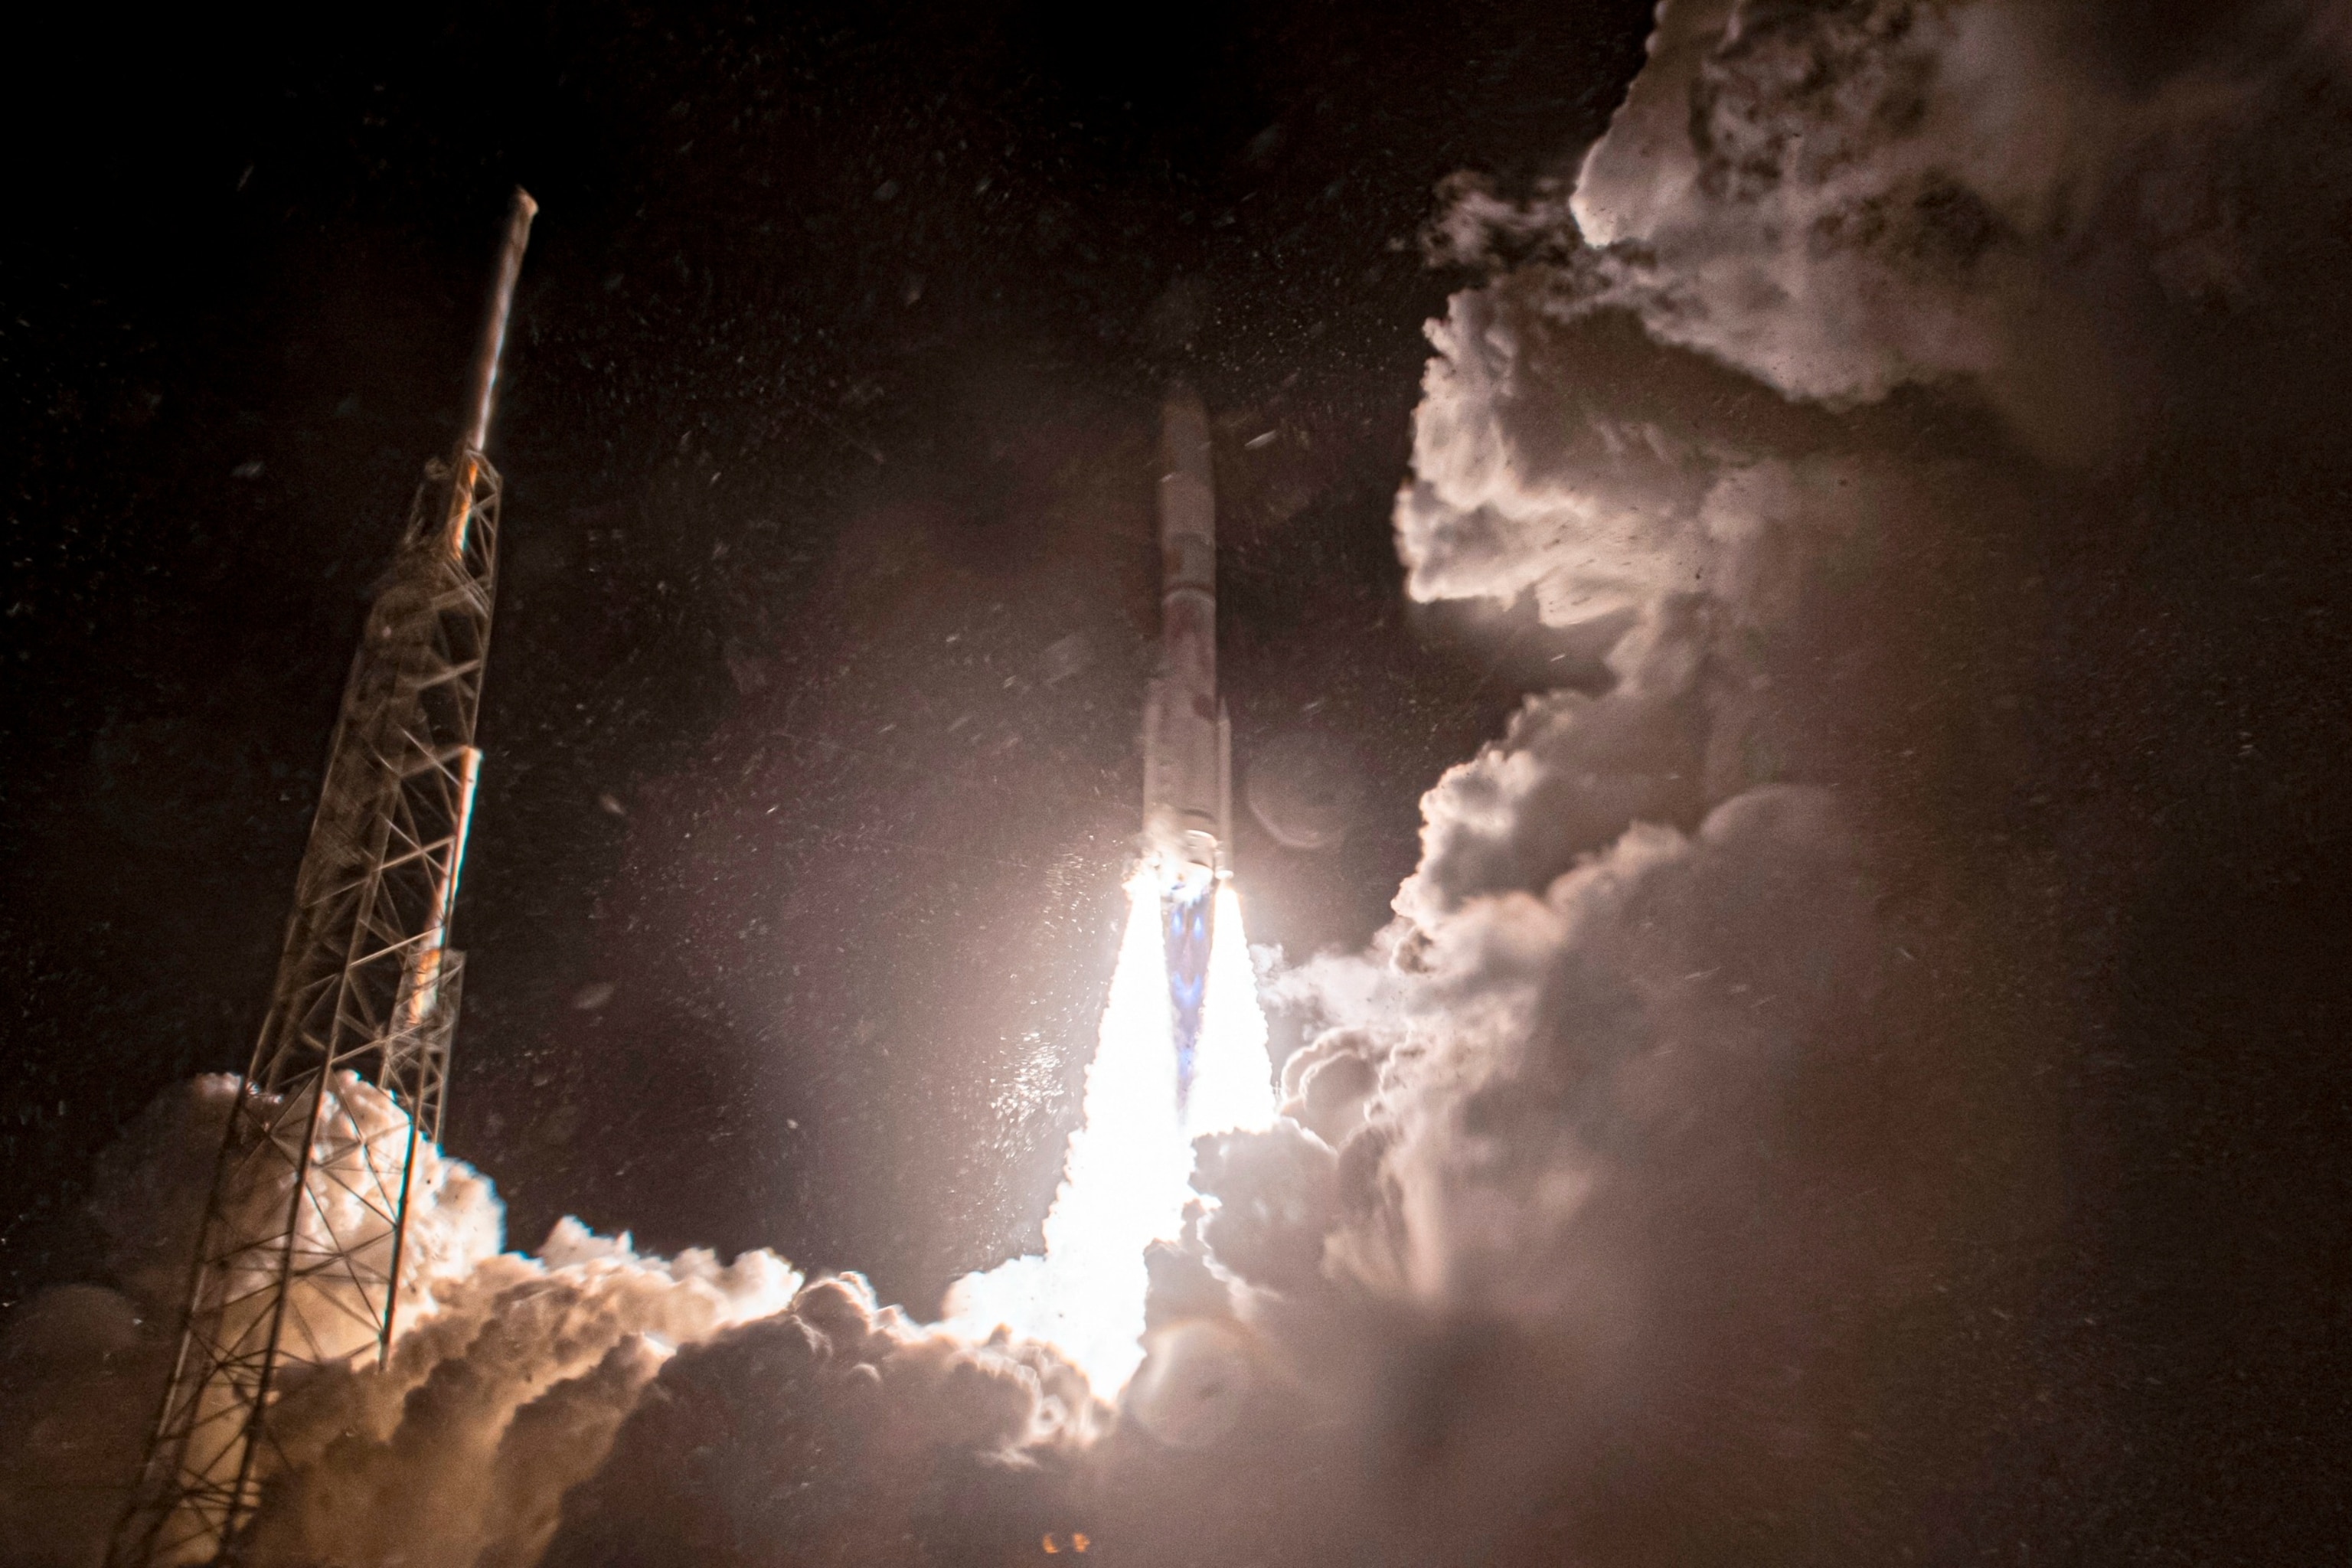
[946,388,1275,1396]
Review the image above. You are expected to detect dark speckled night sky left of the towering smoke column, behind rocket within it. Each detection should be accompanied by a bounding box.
[0,5,1646,1302]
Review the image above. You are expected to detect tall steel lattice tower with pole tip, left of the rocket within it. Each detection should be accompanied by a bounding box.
[106,191,538,1568]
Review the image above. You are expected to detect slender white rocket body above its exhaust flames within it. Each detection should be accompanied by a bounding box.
[1143,388,1233,884]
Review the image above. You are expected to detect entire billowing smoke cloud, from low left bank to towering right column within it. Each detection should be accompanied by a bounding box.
[0,0,2352,1568]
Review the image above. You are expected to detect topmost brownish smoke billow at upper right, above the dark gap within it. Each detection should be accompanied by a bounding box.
[1571,0,2343,461]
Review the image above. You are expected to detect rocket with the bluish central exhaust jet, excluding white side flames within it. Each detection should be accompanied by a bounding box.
[1143,386,1233,1100]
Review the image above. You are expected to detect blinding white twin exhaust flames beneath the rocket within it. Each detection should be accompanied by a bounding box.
[946,865,1275,1396]
